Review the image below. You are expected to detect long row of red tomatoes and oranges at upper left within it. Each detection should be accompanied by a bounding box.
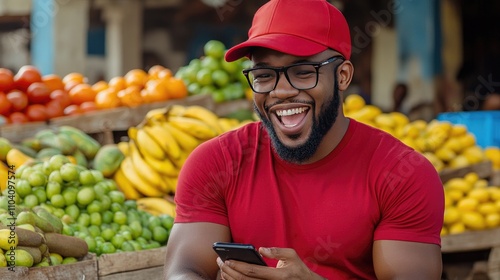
[0,65,188,125]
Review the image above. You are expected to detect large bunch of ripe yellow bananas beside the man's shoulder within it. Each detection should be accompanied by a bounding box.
[114,105,248,199]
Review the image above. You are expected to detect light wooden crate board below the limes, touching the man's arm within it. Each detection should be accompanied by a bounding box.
[97,246,166,280]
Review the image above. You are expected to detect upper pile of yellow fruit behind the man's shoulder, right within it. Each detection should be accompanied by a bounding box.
[344,94,500,171]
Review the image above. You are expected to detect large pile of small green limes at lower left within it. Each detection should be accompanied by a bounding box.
[0,155,173,255]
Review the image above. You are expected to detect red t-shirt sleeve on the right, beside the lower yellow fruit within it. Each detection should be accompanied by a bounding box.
[374,151,444,245]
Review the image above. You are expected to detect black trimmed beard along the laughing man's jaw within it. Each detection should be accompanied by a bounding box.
[254,77,340,164]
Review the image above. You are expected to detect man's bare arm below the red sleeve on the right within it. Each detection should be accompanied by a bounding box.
[373,240,442,280]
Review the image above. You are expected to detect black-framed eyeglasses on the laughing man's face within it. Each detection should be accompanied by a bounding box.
[243,56,344,93]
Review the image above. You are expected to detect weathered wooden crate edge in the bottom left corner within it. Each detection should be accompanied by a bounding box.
[0,254,99,280]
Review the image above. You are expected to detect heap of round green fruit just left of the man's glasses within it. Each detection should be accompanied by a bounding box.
[175,40,251,103]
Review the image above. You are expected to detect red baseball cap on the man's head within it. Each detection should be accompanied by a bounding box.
[225,0,351,61]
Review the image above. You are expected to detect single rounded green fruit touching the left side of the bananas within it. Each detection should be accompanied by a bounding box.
[92,144,125,178]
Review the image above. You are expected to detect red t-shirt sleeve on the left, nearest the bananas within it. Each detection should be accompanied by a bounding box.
[175,138,229,225]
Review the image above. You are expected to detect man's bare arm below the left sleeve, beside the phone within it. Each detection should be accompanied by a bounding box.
[164,223,231,280]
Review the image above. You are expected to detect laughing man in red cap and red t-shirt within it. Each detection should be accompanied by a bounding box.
[165,0,444,279]
